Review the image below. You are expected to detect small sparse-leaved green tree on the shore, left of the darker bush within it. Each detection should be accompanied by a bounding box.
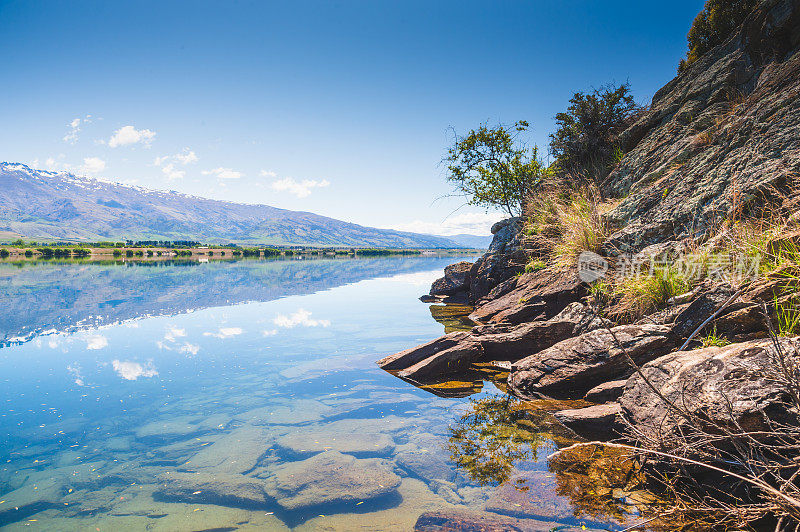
[443,121,548,216]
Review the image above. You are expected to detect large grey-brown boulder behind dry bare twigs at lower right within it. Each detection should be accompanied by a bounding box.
[619,338,800,436]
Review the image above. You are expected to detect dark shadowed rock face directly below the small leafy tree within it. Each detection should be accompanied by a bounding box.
[469,218,527,303]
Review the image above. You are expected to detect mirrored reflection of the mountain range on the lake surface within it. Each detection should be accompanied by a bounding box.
[0,257,462,349]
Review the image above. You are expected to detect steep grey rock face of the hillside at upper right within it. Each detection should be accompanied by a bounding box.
[604,0,800,251]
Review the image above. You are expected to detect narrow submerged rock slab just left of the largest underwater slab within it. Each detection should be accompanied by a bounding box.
[153,472,269,508]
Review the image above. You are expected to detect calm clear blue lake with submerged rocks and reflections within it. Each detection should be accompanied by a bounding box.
[0,256,635,531]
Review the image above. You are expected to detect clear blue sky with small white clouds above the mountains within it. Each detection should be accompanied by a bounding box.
[0,0,703,234]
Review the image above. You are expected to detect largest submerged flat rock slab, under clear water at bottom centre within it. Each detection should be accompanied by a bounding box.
[265,451,400,510]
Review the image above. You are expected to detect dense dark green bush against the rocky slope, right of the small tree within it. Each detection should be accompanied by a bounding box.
[550,83,638,181]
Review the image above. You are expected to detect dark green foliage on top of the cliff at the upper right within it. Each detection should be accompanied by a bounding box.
[678,0,758,72]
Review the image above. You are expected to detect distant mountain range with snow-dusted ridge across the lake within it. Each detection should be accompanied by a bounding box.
[0,163,462,248]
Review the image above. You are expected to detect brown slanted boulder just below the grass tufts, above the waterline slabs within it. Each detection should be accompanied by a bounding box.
[469,268,588,323]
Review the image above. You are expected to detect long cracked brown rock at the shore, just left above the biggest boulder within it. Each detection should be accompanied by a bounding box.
[508,325,674,397]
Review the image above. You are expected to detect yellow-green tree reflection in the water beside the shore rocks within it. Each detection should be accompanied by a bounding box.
[447,395,550,486]
